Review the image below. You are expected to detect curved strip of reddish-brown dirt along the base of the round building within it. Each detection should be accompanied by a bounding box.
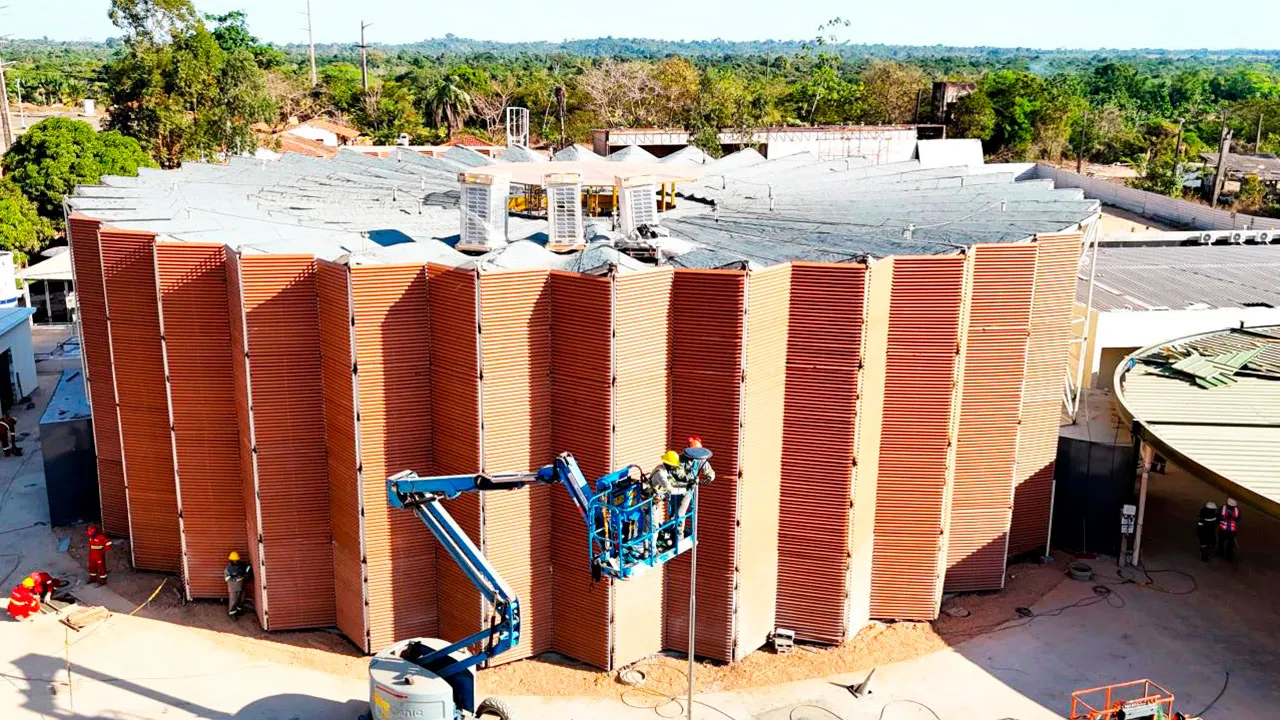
[70,525,1068,705]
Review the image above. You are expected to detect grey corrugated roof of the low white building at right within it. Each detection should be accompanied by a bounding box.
[1075,245,1280,311]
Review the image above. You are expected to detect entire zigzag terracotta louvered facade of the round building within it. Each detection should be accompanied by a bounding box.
[70,212,1079,669]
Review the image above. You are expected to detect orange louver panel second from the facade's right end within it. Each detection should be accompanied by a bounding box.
[945,245,1036,592]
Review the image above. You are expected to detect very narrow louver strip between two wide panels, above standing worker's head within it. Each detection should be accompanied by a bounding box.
[225,250,269,628]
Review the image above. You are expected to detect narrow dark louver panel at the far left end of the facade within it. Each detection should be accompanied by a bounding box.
[67,215,129,537]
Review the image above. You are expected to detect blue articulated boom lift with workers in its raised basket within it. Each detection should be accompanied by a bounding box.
[369,443,712,720]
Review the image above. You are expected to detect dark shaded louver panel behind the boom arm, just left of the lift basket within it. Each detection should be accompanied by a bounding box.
[549,272,613,670]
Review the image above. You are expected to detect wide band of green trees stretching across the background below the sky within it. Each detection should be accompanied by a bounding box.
[0,0,1280,258]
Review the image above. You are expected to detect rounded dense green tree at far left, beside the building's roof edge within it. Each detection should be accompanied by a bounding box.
[3,118,155,227]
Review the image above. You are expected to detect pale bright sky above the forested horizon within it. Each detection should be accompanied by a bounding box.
[0,0,1280,49]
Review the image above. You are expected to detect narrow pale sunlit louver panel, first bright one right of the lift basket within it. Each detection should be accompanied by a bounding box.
[733,264,783,659]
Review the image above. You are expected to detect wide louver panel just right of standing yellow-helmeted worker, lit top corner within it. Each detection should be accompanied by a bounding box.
[239,255,337,630]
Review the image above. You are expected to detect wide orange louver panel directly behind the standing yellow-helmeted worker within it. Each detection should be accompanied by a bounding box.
[155,242,248,598]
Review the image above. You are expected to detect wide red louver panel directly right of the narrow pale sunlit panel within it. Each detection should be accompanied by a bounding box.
[777,264,867,644]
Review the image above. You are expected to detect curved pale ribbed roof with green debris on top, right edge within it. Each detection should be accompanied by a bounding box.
[1116,327,1280,516]
